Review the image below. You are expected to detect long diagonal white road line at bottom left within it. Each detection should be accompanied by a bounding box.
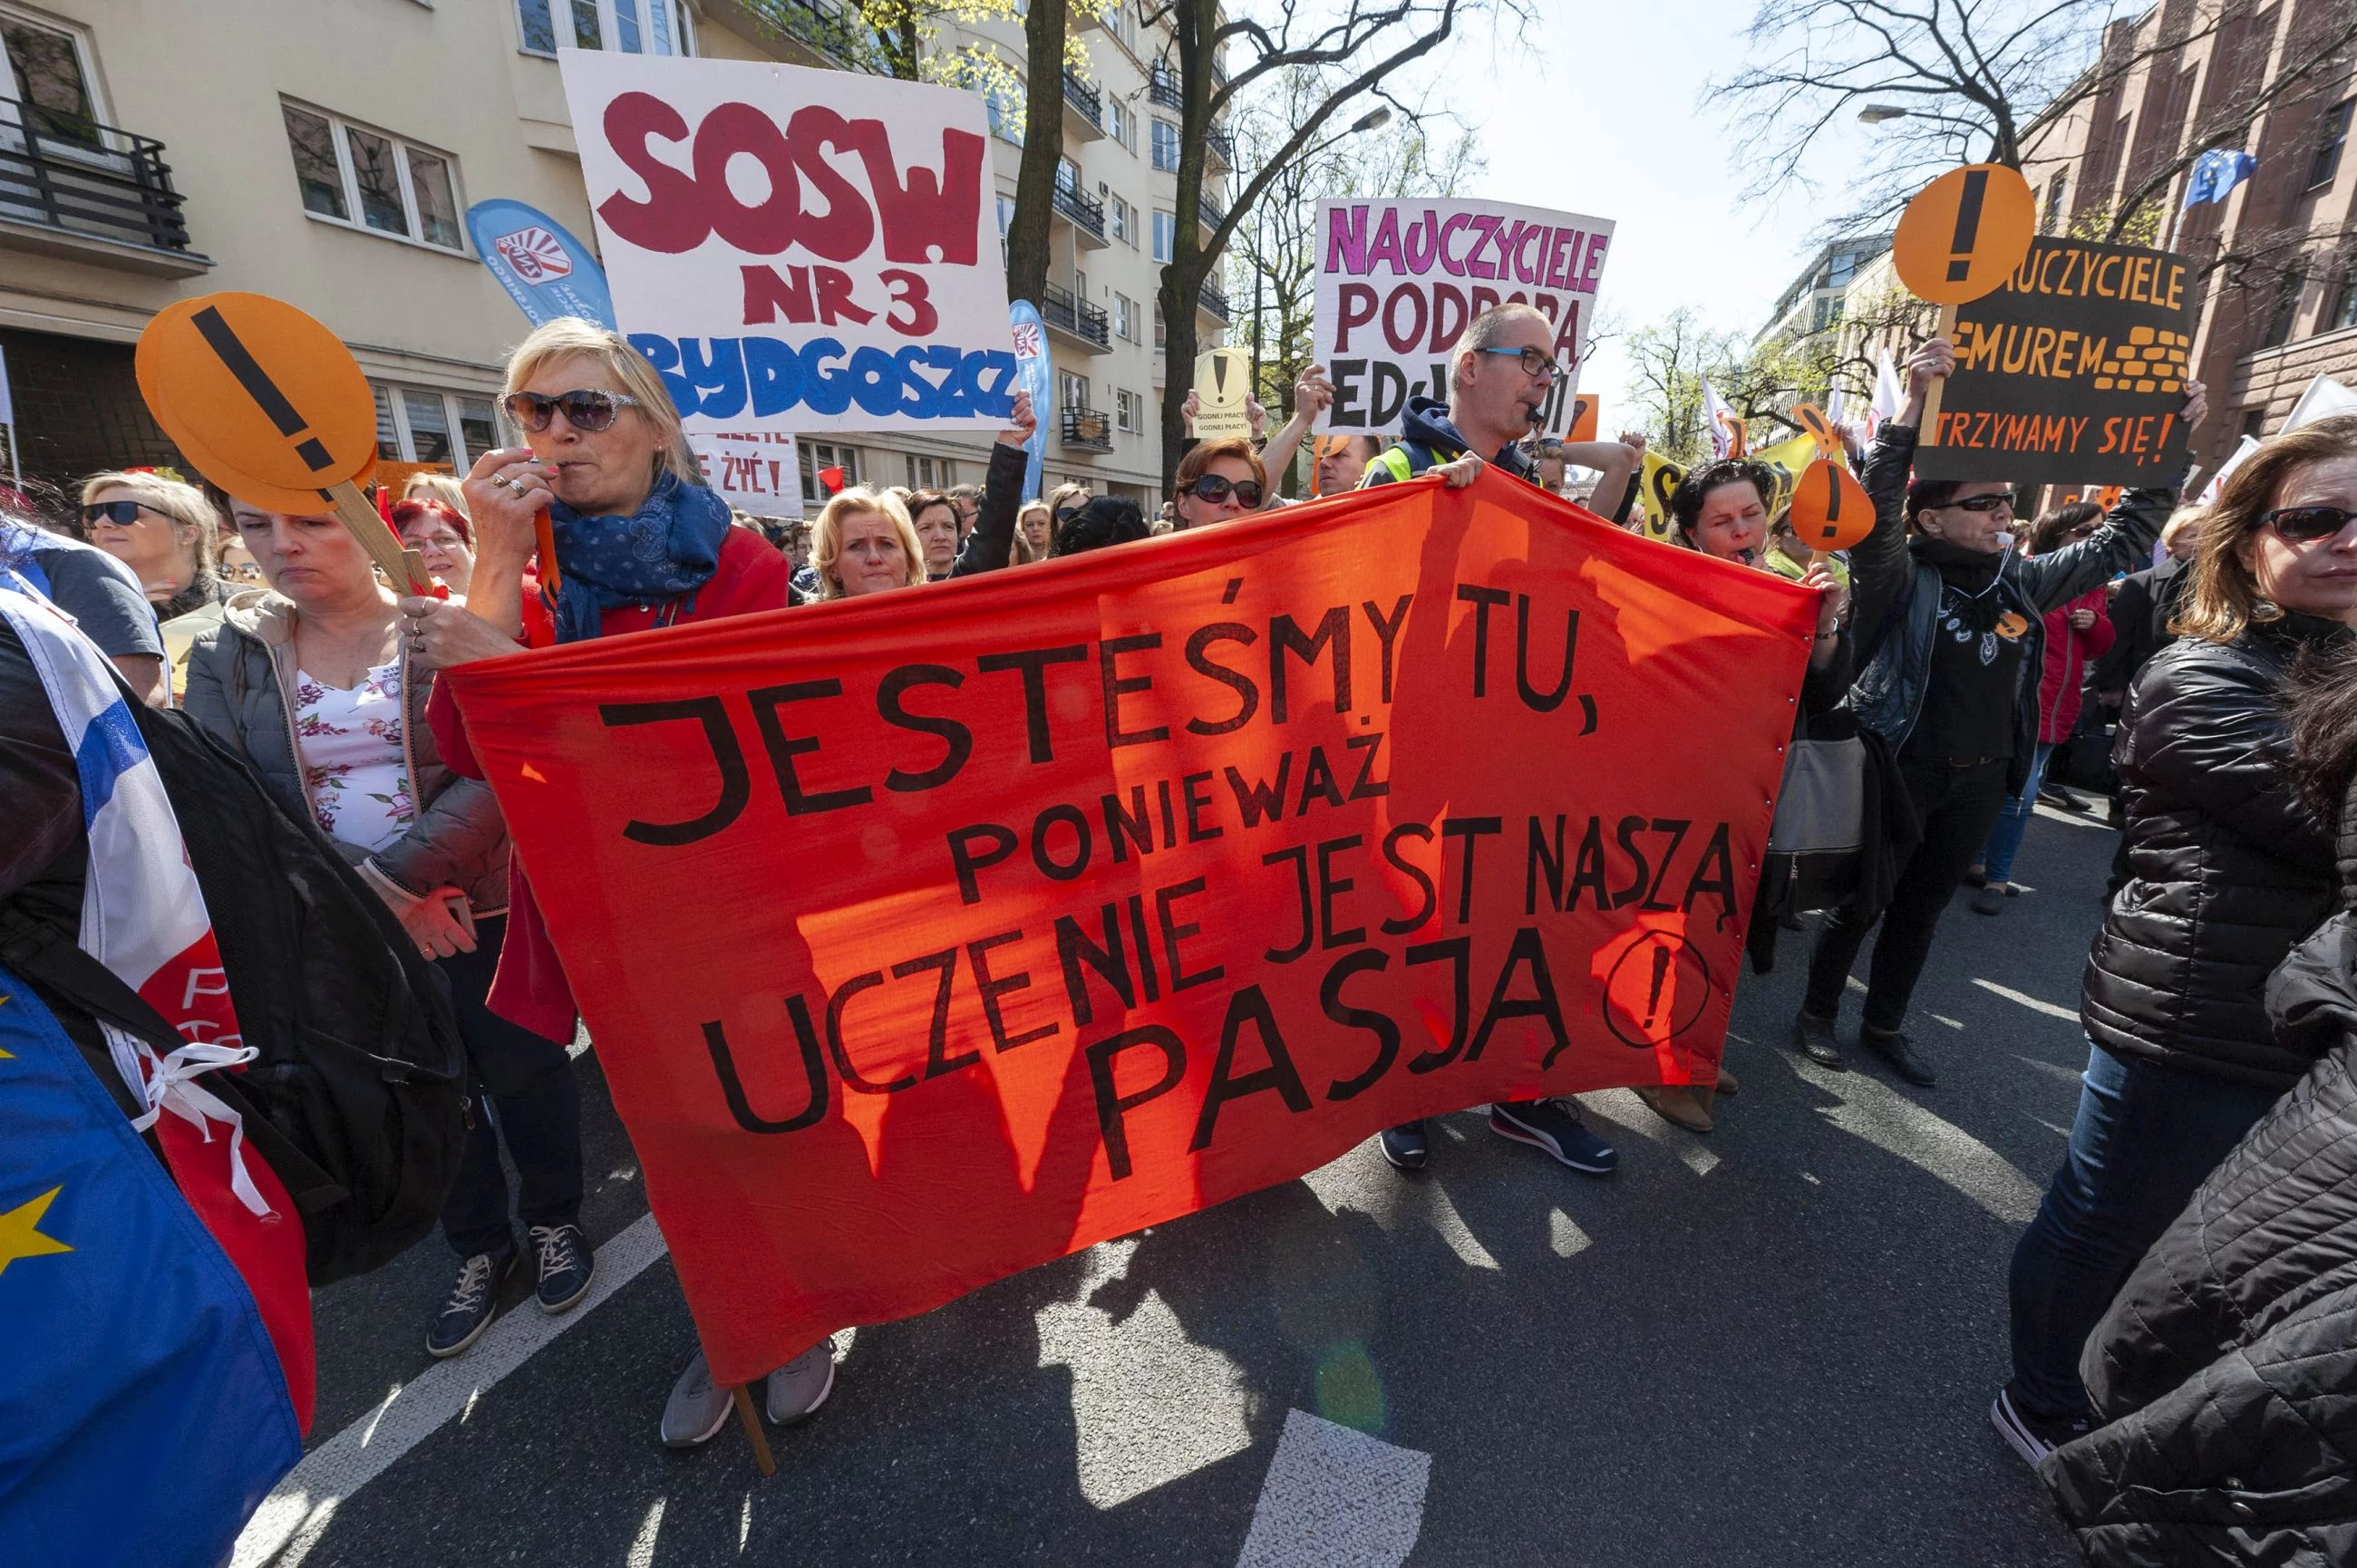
[231,1215,667,1568]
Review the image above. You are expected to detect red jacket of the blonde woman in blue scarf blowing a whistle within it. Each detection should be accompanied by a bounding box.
[427,528,792,1042]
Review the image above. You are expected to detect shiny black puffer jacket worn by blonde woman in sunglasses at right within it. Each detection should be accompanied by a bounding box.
[2079,615,2345,1089]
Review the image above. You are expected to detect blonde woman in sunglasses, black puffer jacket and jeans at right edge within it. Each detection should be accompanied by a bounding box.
[1989,417,2357,1465]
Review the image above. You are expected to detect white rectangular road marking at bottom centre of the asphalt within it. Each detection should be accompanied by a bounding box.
[1235,1410,1433,1568]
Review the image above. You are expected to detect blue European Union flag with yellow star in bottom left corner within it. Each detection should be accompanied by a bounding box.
[0,969,302,1568]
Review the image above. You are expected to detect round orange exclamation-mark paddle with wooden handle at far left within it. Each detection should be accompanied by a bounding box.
[134,293,433,595]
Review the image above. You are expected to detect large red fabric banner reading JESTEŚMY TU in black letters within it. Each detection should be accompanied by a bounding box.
[451,474,1818,1381]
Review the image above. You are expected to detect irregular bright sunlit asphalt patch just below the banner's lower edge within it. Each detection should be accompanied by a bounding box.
[1037,1240,1252,1509]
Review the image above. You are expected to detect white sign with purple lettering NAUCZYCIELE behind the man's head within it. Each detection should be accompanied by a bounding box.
[1313,198,1612,436]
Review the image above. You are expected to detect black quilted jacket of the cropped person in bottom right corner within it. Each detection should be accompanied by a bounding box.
[2042,790,2357,1568]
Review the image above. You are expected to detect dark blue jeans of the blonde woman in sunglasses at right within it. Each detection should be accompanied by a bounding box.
[2011,1047,2279,1415]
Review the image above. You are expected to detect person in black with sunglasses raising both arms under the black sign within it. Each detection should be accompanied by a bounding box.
[1794,337,2208,1087]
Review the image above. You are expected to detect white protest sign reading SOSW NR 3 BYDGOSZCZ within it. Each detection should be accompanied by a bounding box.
[570,50,1016,434]
